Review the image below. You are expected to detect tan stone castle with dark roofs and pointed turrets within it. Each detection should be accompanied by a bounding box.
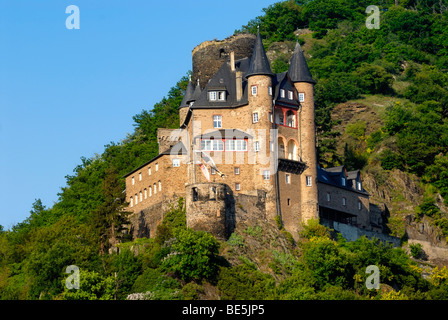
[126,33,392,239]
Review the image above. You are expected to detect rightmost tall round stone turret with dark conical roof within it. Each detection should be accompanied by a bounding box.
[288,42,319,222]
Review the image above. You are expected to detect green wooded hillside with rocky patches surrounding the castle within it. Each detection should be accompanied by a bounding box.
[0,0,448,300]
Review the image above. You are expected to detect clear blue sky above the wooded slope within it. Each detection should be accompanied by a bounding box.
[0,0,278,229]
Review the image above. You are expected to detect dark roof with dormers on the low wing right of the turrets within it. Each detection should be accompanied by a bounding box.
[317,166,369,195]
